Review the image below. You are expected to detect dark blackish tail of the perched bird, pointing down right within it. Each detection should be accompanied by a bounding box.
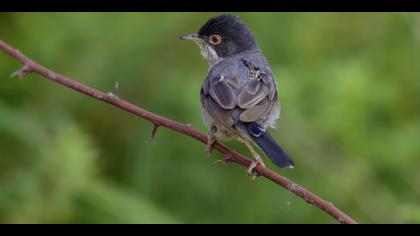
[242,123,295,168]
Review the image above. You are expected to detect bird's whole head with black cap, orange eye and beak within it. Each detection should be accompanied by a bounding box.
[180,14,258,66]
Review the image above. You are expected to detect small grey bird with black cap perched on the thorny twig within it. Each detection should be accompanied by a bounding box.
[180,14,294,175]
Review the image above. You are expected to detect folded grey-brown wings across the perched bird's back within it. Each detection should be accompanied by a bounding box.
[201,56,277,127]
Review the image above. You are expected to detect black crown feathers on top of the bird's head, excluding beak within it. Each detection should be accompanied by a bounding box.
[198,14,258,57]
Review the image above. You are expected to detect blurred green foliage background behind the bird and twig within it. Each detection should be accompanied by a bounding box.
[0,13,420,223]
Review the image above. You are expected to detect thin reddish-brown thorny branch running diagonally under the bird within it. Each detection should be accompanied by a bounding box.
[0,40,357,224]
